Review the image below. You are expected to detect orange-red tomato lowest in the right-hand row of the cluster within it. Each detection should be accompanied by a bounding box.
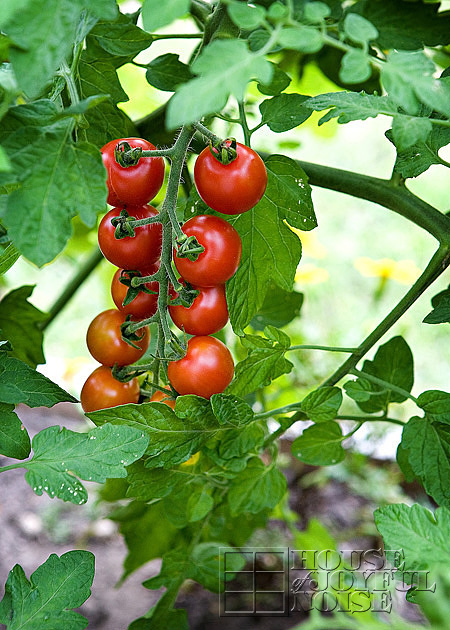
[167,336,234,398]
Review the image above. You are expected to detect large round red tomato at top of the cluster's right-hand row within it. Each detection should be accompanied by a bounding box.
[194,142,267,214]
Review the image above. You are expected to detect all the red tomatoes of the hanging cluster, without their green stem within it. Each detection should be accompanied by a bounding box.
[81,138,267,412]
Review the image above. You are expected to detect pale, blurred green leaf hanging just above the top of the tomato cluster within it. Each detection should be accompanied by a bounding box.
[166,39,272,129]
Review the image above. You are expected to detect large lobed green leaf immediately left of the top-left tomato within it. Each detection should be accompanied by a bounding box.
[5,115,106,265]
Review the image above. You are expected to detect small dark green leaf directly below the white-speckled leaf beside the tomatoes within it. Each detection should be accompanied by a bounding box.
[250,282,303,330]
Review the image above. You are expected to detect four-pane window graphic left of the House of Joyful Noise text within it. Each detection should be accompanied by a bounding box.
[220,547,289,617]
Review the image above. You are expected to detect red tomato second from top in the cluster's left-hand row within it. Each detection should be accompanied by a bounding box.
[98,206,162,270]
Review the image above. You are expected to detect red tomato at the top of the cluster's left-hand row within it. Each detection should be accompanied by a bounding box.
[101,138,164,206]
